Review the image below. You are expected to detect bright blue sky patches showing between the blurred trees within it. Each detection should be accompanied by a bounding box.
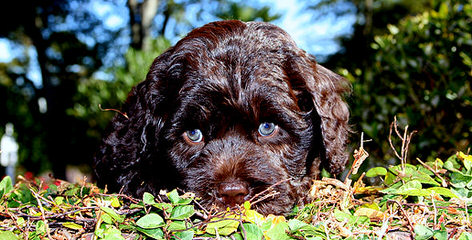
[0,0,356,86]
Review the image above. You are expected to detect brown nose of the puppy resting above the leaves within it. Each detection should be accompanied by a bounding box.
[218,182,249,207]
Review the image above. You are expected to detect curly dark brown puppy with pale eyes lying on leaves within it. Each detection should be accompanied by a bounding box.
[94,20,350,215]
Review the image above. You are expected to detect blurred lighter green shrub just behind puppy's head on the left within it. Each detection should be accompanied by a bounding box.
[67,37,170,139]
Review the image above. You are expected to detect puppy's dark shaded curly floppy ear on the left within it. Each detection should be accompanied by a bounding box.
[94,50,181,195]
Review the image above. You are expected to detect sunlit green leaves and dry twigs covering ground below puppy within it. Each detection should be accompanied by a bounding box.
[0,152,472,240]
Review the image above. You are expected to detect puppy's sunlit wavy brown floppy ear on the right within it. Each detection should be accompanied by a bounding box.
[307,59,351,174]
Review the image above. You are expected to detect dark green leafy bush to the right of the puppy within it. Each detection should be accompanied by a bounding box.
[341,0,472,164]
